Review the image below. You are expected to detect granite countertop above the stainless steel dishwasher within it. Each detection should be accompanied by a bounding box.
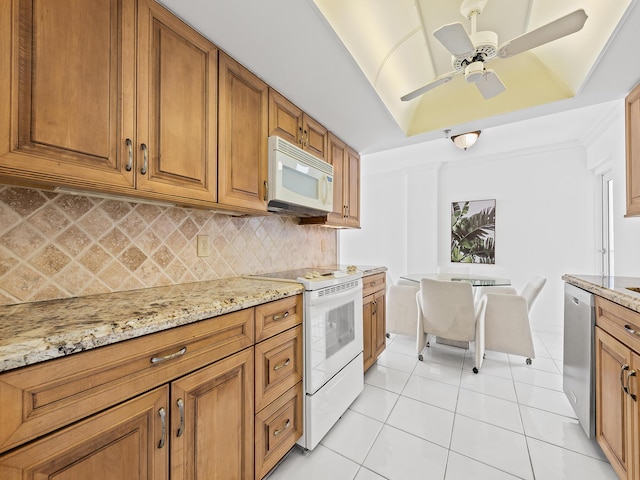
[562,274,640,313]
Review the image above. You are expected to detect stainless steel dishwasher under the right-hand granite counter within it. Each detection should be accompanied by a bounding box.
[562,283,596,438]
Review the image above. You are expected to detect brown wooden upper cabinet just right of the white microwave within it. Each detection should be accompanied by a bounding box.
[300,132,360,228]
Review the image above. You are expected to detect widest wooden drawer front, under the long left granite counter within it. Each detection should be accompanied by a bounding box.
[0,308,254,452]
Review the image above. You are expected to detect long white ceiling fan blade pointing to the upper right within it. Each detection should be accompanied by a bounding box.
[498,9,587,58]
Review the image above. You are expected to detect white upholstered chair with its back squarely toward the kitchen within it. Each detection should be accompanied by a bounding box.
[416,278,484,373]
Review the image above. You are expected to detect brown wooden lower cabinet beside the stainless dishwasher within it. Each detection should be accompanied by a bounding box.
[595,297,640,480]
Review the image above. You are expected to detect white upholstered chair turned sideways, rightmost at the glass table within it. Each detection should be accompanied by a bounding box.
[476,276,547,365]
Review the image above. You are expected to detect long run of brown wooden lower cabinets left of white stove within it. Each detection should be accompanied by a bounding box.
[0,295,302,480]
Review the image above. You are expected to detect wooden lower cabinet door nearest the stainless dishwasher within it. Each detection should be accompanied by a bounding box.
[596,327,632,479]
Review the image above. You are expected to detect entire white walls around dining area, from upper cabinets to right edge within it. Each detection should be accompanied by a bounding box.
[340,102,640,333]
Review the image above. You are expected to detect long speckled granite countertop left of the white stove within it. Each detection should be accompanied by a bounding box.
[0,277,303,372]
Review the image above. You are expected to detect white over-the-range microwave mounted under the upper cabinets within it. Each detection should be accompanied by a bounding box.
[267,136,333,217]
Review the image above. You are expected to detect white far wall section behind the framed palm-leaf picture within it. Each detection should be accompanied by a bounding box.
[438,146,595,333]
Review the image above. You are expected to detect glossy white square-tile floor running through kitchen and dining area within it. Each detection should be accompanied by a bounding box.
[269,333,617,480]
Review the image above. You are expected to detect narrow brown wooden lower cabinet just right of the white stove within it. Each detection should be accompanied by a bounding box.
[362,273,387,372]
